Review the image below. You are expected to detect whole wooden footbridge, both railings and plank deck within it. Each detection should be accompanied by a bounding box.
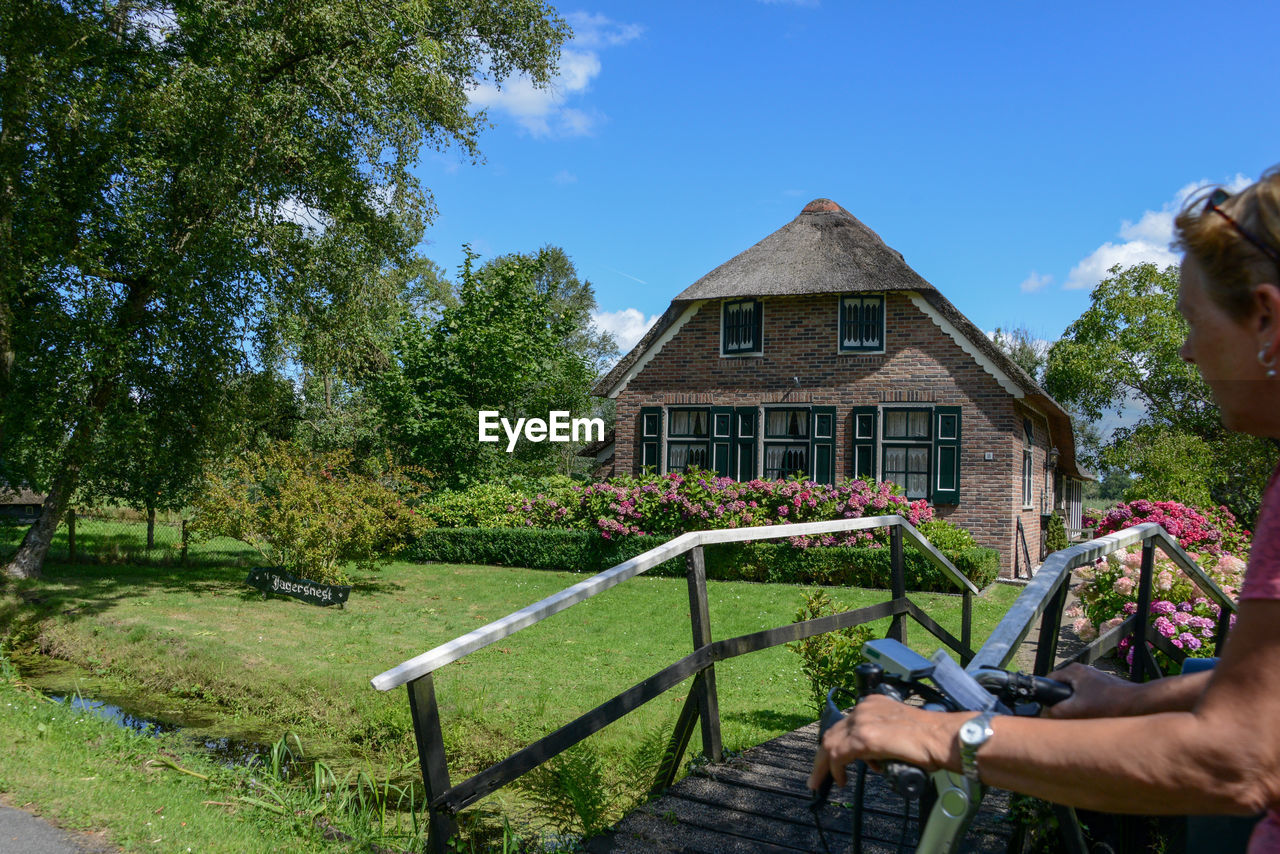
[371,516,1235,854]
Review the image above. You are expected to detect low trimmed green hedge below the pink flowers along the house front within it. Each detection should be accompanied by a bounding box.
[402,528,1000,593]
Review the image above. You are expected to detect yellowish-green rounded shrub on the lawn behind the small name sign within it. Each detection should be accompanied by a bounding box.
[189,442,422,584]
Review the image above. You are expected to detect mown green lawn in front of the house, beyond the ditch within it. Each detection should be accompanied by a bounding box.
[0,563,1020,850]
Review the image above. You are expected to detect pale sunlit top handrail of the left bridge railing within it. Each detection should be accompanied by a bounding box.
[370,515,978,691]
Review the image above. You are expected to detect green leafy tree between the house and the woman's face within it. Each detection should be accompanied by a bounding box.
[1044,264,1276,525]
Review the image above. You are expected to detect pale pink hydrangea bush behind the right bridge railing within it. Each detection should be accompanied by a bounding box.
[1065,547,1245,670]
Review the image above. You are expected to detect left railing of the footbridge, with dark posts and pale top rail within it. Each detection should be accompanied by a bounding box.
[371,515,978,853]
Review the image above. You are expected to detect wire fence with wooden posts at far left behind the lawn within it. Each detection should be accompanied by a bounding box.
[0,507,260,566]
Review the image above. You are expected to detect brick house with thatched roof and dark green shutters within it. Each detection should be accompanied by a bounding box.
[593,198,1089,575]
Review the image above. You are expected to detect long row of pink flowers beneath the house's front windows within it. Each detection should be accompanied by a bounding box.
[520,472,933,547]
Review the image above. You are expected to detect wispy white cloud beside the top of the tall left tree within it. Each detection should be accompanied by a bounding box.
[468,12,644,137]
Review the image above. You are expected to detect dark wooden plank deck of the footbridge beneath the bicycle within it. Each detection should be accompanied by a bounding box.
[586,723,1012,854]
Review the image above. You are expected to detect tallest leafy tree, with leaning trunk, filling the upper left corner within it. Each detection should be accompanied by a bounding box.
[0,0,566,576]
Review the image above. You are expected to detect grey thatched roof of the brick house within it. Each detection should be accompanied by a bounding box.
[593,198,1091,478]
